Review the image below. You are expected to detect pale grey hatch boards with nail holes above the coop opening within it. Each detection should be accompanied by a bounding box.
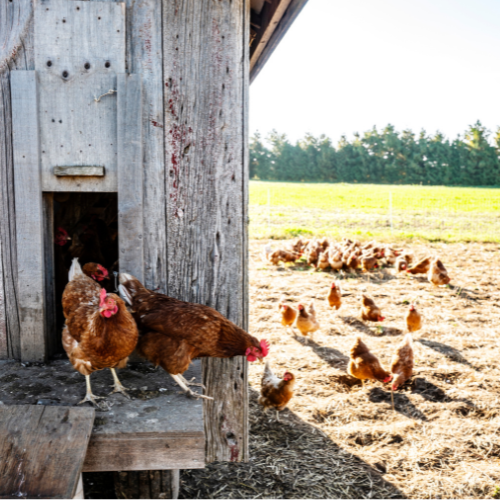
[35,0,125,192]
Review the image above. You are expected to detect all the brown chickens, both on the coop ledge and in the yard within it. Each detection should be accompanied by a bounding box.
[56,226,450,418]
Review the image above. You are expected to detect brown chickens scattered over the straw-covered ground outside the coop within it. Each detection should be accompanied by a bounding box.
[259,238,450,420]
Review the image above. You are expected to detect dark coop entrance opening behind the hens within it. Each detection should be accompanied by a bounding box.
[53,192,118,344]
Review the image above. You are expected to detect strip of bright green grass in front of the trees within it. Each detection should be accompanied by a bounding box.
[250,181,500,242]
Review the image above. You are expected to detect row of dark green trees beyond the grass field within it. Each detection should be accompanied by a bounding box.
[250,121,500,186]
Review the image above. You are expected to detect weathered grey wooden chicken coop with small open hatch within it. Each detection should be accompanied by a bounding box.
[0,0,307,498]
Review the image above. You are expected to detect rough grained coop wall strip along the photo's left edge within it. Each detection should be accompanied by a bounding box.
[0,0,34,359]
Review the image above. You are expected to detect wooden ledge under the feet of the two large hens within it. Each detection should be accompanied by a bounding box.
[0,360,205,472]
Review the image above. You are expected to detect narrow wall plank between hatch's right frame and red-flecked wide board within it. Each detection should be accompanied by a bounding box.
[127,0,167,292]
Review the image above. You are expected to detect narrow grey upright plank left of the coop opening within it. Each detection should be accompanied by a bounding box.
[11,71,47,361]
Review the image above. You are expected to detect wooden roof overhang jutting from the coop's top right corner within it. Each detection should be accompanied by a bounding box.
[250,0,308,83]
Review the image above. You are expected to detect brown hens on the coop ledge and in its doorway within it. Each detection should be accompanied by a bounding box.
[55,230,269,407]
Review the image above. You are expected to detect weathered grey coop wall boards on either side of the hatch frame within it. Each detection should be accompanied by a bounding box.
[0,0,249,461]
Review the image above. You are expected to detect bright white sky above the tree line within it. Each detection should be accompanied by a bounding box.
[250,0,500,144]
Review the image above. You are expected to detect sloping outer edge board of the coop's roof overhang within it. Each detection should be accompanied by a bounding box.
[250,0,308,83]
